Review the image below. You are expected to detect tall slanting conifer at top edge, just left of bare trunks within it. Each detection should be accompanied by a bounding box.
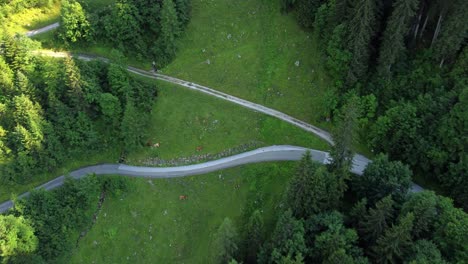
[377,0,418,78]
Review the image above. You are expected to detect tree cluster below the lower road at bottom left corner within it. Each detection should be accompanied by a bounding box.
[0,175,131,264]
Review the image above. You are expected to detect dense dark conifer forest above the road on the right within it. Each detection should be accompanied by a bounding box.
[281,0,468,209]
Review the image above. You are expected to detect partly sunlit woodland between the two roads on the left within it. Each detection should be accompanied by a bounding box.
[0,36,156,184]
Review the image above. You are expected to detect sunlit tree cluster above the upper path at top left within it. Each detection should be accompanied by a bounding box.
[60,0,191,67]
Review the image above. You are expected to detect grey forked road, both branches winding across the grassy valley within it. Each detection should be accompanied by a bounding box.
[0,23,423,213]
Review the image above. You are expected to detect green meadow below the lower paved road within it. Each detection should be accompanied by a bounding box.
[70,162,295,263]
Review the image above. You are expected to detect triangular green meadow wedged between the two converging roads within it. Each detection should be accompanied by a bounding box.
[128,78,328,164]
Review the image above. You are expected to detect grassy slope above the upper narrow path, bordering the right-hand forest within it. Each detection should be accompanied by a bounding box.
[163,0,328,124]
